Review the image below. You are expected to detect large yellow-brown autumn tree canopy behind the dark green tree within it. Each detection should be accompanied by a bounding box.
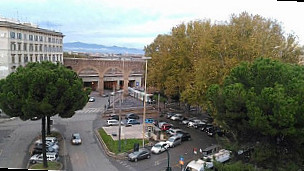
[145,12,301,106]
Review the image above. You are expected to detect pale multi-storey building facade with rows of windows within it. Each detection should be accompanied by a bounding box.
[0,17,64,79]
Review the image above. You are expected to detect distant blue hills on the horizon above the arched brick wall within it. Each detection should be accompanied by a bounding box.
[63,42,144,54]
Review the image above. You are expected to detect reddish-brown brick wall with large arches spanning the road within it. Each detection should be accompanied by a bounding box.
[63,57,145,94]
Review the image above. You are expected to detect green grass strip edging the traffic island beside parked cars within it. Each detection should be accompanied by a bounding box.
[98,128,149,154]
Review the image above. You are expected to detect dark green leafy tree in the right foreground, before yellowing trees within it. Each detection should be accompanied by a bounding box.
[208,58,304,170]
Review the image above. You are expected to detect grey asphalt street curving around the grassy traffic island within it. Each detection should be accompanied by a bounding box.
[0,92,216,171]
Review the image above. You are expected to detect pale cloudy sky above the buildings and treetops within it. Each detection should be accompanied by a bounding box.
[0,0,304,49]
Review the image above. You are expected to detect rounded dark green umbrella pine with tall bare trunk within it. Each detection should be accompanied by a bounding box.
[0,62,88,167]
